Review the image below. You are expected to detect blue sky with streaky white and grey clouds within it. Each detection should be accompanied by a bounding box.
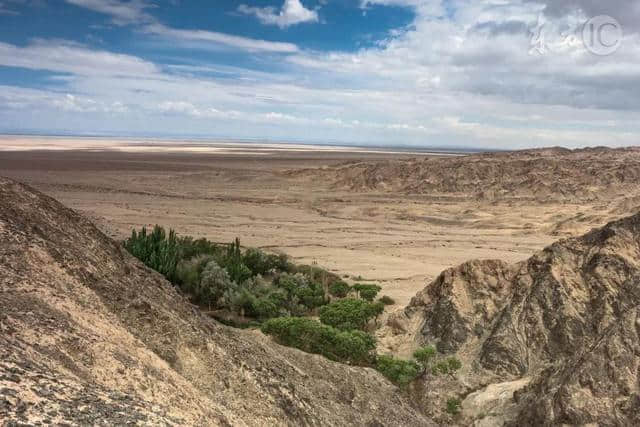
[0,0,640,149]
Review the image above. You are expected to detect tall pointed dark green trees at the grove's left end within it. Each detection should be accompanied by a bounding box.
[124,225,181,283]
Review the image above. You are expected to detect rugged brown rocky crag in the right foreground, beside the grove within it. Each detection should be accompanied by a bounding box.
[389,210,640,426]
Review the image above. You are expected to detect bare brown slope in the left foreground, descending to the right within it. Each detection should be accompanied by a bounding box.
[0,178,430,426]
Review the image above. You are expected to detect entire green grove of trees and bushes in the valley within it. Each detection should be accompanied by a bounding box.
[124,226,412,372]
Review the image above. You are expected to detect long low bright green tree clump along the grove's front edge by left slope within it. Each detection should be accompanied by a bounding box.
[261,317,376,364]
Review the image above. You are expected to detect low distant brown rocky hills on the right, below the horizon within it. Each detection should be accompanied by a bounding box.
[291,148,640,202]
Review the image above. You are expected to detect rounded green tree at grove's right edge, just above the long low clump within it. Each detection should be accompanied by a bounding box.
[320,298,384,331]
